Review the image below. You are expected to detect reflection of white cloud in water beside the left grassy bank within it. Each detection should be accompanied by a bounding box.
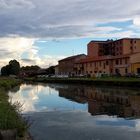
[9,84,57,113]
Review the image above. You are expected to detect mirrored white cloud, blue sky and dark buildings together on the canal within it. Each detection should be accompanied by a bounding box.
[9,84,140,118]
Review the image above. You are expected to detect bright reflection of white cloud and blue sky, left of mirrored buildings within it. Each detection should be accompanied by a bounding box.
[9,84,87,113]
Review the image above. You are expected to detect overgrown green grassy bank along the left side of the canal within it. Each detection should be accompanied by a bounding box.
[0,77,31,140]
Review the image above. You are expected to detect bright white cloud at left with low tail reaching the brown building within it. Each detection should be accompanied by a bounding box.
[0,37,66,68]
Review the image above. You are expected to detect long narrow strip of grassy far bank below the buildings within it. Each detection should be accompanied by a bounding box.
[24,77,140,88]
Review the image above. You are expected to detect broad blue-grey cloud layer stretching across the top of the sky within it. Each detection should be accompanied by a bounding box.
[0,0,140,39]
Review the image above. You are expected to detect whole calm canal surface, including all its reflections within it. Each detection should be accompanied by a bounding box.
[9,84,140,140]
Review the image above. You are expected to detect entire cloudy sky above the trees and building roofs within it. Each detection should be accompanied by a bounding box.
[0,0,140,67]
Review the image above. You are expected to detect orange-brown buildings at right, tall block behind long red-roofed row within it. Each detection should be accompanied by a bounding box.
[75,38,140,76]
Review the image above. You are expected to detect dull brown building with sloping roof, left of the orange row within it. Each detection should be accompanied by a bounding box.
[59,54,86,75]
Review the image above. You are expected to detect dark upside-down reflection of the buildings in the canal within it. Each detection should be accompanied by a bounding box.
[58,86,140,118]
